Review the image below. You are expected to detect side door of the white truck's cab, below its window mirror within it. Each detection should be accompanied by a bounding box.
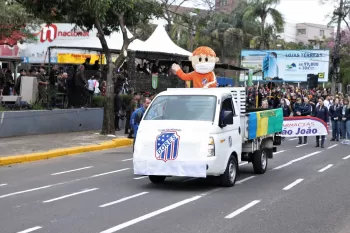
[219,95,242,162]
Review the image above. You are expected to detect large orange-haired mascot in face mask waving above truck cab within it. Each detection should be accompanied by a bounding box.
[171,46,219,88]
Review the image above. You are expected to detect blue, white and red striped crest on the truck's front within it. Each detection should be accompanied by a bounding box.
[155,131,180,162]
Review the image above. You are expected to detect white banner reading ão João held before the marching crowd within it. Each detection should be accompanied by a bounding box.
[282,116,328,137]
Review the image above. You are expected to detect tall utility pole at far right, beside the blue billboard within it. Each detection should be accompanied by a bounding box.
[331,0,344,95]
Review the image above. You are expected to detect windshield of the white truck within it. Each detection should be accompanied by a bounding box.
[144,95,216,121]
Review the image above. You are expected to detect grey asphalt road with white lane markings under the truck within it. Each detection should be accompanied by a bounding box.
[0,138,350,233]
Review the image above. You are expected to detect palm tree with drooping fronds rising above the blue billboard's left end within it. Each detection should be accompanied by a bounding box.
[244,0,284,49]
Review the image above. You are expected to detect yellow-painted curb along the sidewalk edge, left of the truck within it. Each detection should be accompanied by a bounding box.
[0,138,133,166]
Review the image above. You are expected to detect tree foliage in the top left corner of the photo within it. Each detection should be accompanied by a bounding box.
[0,0,38,46]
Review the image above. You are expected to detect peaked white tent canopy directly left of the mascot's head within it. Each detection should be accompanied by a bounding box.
[136,25,192,56]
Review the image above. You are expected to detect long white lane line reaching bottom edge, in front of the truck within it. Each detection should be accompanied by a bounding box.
[101,195,203,233]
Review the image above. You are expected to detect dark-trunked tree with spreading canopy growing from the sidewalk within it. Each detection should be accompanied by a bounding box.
[18,0,163,134]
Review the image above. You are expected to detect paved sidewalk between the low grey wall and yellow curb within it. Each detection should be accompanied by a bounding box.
[0,131,127,158]
